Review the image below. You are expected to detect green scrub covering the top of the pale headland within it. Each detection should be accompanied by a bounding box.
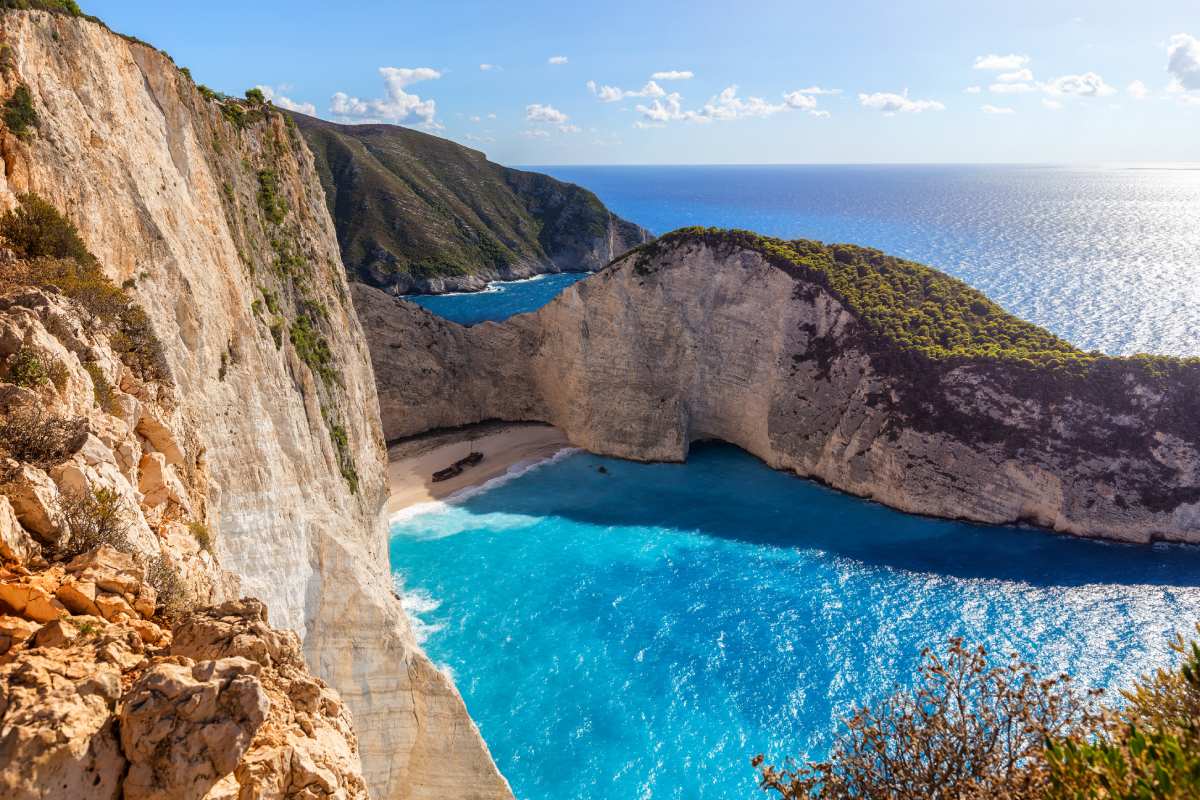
[633,228,1200,377]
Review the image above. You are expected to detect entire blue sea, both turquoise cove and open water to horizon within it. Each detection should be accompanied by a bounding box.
[391,167,1200,800]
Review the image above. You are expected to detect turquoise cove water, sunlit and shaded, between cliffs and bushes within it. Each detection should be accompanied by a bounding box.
[390,445,1200,800]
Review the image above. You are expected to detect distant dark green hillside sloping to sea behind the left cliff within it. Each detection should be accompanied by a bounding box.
[293,114,649,294]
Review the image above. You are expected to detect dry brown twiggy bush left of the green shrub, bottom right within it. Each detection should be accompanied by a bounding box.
[752,639,1097,800]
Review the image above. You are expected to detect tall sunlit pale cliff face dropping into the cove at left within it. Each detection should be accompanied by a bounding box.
[0,12,509,798]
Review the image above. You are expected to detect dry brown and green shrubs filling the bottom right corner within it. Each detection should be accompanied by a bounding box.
[752,639,1200,800]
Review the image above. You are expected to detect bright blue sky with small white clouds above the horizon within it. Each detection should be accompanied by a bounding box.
[82,0,1200,164]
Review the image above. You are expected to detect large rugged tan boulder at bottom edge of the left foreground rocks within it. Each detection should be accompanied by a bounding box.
[120,658,270,800]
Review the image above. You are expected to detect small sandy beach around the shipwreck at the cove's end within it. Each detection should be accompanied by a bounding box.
[388,422,570,515]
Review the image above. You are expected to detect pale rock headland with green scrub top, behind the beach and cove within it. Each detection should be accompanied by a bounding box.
[355,231,1200,542]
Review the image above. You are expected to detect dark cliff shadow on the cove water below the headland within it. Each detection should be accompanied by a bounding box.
[446,443,1200,588]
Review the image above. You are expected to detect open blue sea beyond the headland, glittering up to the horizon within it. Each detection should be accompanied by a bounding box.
[417,166,1200,355]
